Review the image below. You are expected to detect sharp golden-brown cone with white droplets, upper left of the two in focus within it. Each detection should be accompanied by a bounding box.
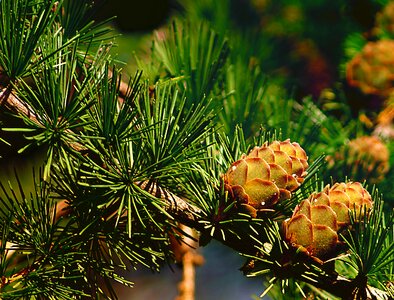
[224,140,308,216]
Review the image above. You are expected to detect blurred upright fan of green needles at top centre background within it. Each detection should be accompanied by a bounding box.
[146,20,229,105]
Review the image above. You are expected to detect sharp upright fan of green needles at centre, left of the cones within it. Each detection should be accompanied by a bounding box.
[136,83,215,181]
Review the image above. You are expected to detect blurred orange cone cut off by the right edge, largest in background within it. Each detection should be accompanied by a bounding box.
[346,40,394,97]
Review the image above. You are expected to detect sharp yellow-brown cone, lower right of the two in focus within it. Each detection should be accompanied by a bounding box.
[283,182,372,259]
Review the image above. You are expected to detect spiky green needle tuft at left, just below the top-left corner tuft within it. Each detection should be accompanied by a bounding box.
[5,42,92,179]
